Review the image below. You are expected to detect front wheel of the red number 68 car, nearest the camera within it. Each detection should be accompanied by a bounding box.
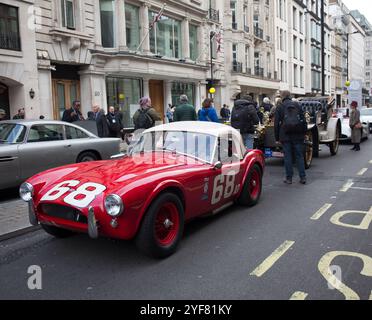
[136,192,184,259]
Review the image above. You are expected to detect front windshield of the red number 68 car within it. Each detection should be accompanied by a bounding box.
[131,131,217,163]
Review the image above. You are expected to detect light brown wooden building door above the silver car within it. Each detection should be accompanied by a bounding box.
[53,79,80,120]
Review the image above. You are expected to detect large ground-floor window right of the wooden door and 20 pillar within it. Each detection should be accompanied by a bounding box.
[106,77,142,128]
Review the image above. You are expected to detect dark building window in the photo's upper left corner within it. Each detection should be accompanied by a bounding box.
[0,4,21,51]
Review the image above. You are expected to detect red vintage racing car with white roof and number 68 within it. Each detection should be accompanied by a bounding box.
[20,122,264,258]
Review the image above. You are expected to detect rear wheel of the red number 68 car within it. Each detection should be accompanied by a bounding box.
[238,164,262,207]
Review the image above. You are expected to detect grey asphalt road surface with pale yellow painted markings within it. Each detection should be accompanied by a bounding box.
[0,140,372,300]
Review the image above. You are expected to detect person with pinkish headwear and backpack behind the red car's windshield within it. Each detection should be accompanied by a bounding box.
[133,97,161,130]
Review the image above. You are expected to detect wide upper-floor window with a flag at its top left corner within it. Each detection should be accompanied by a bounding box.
[149,11,182,58]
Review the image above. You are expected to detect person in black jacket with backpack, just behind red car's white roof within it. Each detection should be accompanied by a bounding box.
[231,95,259,149]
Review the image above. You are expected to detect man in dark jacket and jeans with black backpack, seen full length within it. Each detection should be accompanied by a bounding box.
[275,91,307,184]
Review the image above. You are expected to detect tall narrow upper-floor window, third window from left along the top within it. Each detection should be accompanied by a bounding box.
[100,0,115,48]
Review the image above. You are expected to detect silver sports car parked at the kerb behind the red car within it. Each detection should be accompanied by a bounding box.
[0,120,120,189]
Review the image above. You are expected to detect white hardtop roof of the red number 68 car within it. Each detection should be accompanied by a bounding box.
[144,121,241,138]
